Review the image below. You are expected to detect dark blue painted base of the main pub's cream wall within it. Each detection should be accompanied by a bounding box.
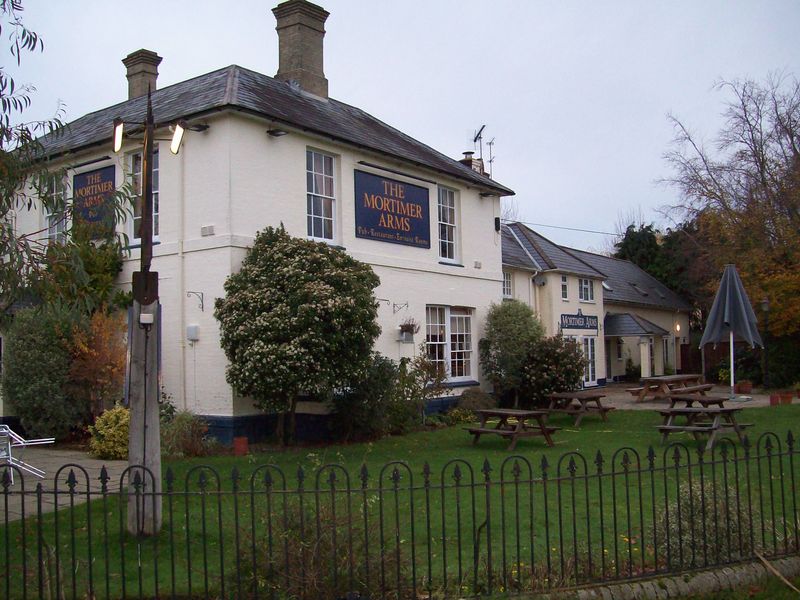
[199,397,458,446]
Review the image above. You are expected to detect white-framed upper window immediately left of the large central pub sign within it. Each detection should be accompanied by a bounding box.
[306,150,336,242]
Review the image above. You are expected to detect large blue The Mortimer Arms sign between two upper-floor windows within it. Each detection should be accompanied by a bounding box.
[355,170,431,248]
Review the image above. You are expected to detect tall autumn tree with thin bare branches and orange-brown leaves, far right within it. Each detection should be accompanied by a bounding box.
[666,77,800,335]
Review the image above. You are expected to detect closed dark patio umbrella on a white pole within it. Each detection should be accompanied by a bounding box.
[700,265,764,398]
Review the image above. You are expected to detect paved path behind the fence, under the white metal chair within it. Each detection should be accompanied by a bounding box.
[0,446,128,523]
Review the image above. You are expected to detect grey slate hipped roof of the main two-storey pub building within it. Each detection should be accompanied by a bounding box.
[41,65,514,196]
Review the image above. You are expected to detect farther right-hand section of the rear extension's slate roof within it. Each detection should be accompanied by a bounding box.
[571,250,692,311]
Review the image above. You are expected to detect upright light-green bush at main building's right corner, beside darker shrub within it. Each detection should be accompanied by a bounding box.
[478,300,544,407]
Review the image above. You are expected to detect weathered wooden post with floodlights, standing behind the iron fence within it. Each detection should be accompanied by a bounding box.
[128,91,161,535]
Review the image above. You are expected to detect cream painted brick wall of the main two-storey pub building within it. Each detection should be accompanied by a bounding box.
[6,113,502,416]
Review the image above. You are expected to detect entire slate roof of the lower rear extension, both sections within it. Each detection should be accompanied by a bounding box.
[502,223,692,314]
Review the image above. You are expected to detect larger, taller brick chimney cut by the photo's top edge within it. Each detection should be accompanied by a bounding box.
[272,0,330,98]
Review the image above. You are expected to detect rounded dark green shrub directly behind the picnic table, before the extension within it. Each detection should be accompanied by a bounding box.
[521,335,586,406]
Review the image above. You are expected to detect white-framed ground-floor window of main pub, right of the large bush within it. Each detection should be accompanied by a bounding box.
[425,306,472,381]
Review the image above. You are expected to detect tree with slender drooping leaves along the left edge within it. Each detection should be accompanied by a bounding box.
[0,0,130,323]
